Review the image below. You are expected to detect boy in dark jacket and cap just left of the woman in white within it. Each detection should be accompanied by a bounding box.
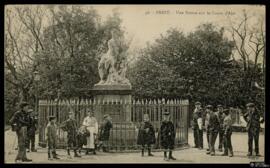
[60,112,81,157]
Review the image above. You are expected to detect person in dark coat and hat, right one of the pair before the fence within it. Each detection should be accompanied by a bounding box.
[160,110,176,161]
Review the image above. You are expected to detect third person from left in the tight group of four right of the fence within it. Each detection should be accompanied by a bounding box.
[216,105,225,152]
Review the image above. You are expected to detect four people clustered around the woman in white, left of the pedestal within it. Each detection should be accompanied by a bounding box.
[46,109,113,160]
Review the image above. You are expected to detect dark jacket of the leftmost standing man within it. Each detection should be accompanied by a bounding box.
[9,110,30,131]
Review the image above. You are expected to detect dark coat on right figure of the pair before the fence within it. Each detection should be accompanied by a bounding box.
[160,121,175,147]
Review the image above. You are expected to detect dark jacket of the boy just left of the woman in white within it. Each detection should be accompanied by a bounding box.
[60,119,78,142]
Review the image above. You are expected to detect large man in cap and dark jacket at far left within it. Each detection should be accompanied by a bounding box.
[10,102,32,163]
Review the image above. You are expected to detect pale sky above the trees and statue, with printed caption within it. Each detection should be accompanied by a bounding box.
[88,5,265,50]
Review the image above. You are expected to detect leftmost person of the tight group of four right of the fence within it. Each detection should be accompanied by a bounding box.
[193,102,203,149]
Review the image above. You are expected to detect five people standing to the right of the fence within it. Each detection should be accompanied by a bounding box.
[192,102,264,157]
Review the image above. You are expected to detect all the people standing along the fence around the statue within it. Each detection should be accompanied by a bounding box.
[10,102,264,162]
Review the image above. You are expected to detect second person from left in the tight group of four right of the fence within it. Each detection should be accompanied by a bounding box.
[206,105,219,156]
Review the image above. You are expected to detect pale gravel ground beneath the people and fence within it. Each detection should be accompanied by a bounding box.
[5,130,264,164]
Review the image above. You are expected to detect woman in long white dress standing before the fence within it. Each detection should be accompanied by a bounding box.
[82,110,98,155]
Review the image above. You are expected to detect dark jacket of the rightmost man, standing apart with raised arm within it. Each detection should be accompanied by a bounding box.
[244,110,261,130]
